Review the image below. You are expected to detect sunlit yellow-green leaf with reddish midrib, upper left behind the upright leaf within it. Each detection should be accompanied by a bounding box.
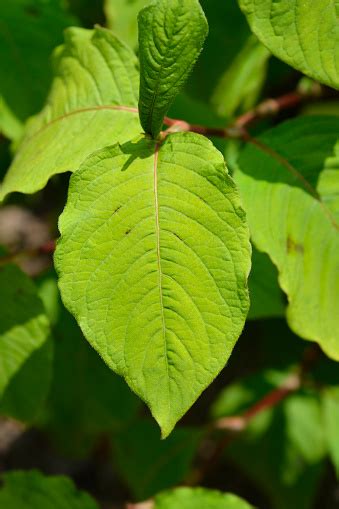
[0,28,141,199]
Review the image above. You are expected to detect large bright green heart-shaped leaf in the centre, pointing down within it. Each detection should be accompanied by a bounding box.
[55,133,250,437]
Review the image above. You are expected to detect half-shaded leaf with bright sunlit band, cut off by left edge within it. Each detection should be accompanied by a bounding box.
[0,265,52,420]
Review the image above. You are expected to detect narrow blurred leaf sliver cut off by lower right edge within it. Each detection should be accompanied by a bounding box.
[322,386,339,477]
